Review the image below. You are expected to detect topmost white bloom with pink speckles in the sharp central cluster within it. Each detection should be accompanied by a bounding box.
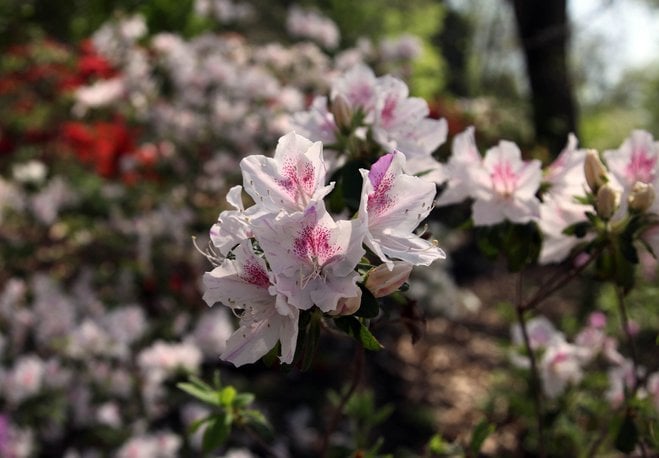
[240,132,334,213]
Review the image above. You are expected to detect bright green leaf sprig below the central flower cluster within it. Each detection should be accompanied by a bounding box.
[176,372,272,454]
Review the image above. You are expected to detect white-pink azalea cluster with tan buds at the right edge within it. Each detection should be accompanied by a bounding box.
[437,128,659,264]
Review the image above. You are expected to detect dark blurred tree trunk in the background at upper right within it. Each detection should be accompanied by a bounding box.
[513,0,577,156]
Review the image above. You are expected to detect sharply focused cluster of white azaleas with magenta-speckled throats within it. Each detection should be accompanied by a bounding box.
[204,132,444,366]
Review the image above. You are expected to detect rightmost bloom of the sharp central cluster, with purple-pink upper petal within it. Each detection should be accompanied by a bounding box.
[358,151,446,269]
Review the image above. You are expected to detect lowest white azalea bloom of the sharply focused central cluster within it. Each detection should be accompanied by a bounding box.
[203,241,299,366]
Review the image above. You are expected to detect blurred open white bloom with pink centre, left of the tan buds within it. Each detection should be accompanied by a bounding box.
[472,141,542,226]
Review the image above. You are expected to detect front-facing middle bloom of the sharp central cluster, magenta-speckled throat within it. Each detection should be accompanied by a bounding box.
[253,201,364,312]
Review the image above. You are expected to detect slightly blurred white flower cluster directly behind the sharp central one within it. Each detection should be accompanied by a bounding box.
[294,65,448,182]
